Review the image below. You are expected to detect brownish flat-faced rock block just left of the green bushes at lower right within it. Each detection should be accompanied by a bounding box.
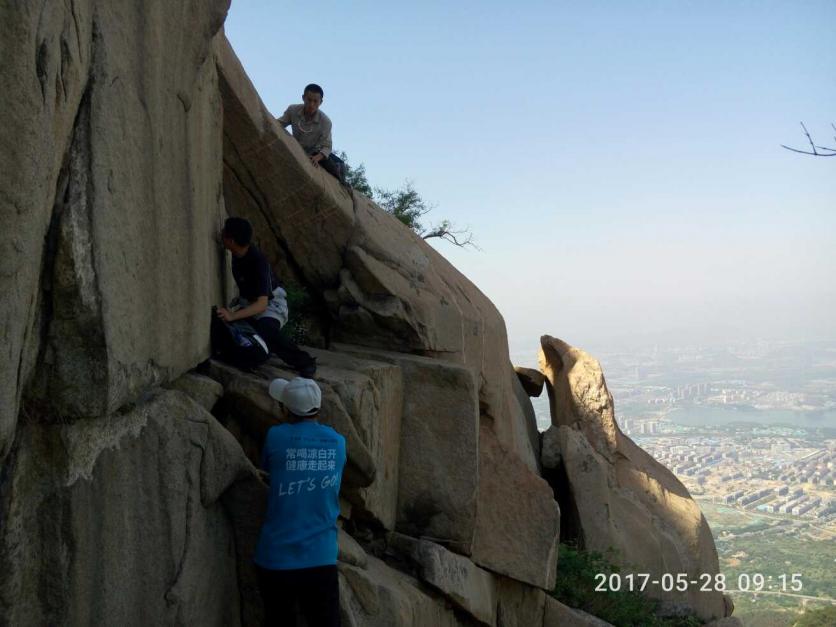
[472,426,560,590]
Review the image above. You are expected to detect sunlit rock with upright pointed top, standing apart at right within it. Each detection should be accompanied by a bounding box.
[540,335,725,620]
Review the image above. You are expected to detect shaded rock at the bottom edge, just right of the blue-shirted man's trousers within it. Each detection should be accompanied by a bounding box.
[338,556,459,627]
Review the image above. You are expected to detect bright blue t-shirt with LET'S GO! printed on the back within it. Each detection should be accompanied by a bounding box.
[255,420,345,570]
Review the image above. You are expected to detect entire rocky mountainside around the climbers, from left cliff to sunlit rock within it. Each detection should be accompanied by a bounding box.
[0,0,722,627]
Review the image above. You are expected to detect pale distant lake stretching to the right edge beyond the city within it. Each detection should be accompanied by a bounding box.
[667,405,836,429]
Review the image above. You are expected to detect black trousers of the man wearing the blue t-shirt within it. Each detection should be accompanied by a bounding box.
[256,565,340,627]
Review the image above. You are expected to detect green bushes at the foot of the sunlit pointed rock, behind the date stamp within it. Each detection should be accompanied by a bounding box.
[552,543,702,627]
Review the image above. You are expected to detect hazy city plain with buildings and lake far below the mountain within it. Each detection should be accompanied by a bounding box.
[520,341,836,625]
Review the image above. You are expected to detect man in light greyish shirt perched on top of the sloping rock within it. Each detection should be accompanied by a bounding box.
[277,83,344,181]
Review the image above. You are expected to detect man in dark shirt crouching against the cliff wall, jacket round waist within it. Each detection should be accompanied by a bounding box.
[217,218,316,378]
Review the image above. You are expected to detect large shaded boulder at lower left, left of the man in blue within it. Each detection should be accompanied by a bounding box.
[0,391,259,626]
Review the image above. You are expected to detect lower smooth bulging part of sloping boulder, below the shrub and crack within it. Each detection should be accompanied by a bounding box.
[334,199,538,474]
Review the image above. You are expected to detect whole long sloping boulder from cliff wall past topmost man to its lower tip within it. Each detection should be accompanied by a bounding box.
[217,38,537,471]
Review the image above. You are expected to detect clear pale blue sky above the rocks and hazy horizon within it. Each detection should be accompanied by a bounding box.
[225,0,836,354]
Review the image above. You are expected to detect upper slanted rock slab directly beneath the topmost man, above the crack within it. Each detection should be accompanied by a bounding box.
[215,37,354,288]
